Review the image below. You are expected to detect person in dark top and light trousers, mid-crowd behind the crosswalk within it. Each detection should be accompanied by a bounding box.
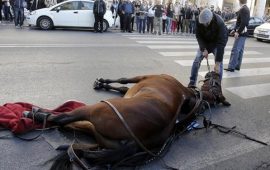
[153,0,164,35]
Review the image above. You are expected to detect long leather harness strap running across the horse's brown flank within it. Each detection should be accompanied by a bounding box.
[101,100,158,156]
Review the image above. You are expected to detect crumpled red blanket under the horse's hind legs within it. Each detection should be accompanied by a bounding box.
[0,101,85,133]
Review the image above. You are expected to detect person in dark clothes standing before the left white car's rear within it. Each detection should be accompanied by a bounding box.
[93,0,106,33]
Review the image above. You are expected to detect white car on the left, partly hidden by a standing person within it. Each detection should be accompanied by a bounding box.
[26,0,117,32]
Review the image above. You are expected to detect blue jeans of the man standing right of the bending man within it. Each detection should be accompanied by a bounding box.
[228,36,247,69]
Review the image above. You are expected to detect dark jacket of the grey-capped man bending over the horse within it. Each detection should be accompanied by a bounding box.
[196,13,228,62]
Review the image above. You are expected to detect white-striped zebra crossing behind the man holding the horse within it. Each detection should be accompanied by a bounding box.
[123,34,270,99]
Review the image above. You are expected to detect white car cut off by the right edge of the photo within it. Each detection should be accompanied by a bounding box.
[253,19,270,41]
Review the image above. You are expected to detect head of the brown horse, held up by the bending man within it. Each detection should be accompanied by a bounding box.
[201,71,231,106]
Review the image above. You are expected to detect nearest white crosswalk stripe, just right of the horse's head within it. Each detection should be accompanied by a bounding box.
[226,83,270,99]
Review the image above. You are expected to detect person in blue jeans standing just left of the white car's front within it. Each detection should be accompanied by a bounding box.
[14,0,26,28]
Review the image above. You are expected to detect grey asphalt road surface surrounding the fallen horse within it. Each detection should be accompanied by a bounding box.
[0,24,270,170]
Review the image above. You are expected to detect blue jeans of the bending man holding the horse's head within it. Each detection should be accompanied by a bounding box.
[189,49,223,86]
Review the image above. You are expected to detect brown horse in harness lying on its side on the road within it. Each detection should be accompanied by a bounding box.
[27,72,230,169]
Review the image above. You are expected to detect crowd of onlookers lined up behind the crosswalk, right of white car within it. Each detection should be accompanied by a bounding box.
[111,0,236,35]
